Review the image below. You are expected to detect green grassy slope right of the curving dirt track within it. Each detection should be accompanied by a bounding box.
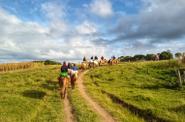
[84,61,185,122]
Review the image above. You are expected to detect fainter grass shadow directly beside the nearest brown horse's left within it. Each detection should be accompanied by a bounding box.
[41,80,59,91]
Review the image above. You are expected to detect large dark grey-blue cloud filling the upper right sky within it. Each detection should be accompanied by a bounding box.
[113,0,185,40]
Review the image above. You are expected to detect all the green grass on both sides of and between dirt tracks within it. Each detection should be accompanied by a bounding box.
[0,61,185,122]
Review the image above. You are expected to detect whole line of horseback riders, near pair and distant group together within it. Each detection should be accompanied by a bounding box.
[58,56,117,98]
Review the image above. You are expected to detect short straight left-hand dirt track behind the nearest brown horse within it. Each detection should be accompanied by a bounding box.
[64,92,74,122]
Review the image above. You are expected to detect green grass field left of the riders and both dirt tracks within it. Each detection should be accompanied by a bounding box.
[0,66,64,122]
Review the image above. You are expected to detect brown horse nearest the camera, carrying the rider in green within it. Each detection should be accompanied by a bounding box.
[58,77,69,99]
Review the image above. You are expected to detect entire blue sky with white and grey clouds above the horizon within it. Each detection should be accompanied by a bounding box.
[0,0,185,63]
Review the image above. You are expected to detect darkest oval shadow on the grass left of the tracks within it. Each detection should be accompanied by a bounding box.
[22,90,46,99]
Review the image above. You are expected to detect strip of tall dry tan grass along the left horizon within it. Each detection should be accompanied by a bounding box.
[0,62,43,72]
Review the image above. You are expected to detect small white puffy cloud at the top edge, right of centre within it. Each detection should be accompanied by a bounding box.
[90,0,113,17]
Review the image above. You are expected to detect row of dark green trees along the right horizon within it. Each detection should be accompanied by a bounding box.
[118,51,183,62]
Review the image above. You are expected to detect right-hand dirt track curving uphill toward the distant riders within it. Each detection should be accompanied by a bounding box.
[77,71,115,122]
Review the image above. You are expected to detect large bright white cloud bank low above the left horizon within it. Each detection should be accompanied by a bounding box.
[0,9,105,62]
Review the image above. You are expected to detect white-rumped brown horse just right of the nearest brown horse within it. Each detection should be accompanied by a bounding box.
[68,69,78,89]
